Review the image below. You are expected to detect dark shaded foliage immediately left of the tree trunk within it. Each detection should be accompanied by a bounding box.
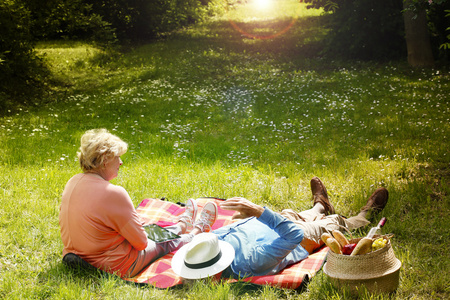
[306,0,406,60]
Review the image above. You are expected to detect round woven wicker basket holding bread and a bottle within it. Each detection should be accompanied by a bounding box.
[323,237,402,293]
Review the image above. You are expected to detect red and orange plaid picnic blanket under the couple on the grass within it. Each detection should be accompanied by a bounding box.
[125,198,328,289]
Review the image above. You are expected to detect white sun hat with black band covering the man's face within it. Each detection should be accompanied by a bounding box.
[172,232,234,279]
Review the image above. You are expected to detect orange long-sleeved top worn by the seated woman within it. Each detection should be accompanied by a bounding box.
[59,173,147,276]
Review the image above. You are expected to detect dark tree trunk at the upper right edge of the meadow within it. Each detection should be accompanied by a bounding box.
[403,0,434,67]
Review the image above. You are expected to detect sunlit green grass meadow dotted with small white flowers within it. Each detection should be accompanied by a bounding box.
[0,0,450,299]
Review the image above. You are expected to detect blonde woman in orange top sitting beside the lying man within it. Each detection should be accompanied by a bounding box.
[59,129,217,277]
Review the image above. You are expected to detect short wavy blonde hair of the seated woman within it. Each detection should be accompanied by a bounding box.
[77,128,128,172]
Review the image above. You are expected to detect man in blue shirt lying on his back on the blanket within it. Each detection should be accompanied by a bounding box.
[172,177,388,279]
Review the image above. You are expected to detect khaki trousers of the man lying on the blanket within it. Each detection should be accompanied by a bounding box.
[281,209,370,254]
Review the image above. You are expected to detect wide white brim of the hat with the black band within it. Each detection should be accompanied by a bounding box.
[172,241,235,279]
